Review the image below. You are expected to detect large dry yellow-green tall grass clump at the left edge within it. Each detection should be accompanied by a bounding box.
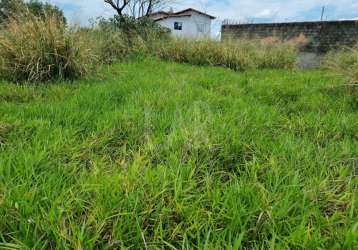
[0,10,96,82]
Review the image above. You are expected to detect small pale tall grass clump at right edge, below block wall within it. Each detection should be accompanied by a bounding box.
[323,44,358,86]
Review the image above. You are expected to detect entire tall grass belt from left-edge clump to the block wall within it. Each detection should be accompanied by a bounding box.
[0,10,297,82]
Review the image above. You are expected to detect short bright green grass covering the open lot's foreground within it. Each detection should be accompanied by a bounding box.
[0,59,358,249]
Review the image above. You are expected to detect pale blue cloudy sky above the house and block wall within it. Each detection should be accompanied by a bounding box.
[48,0,358,24]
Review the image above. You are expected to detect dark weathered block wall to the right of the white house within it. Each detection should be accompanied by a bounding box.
[221,21,358,53]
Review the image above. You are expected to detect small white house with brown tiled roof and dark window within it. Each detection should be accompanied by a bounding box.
[150,9,215,38]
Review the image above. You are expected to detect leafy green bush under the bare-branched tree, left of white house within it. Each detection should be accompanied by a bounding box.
[87,17,169,64]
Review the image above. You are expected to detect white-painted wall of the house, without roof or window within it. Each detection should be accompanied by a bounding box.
[158,12,211,38]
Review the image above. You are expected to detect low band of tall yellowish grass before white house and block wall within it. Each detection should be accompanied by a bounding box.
[154,39,298,71]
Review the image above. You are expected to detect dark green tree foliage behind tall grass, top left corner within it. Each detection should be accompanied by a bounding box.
[0,0,66,23]
